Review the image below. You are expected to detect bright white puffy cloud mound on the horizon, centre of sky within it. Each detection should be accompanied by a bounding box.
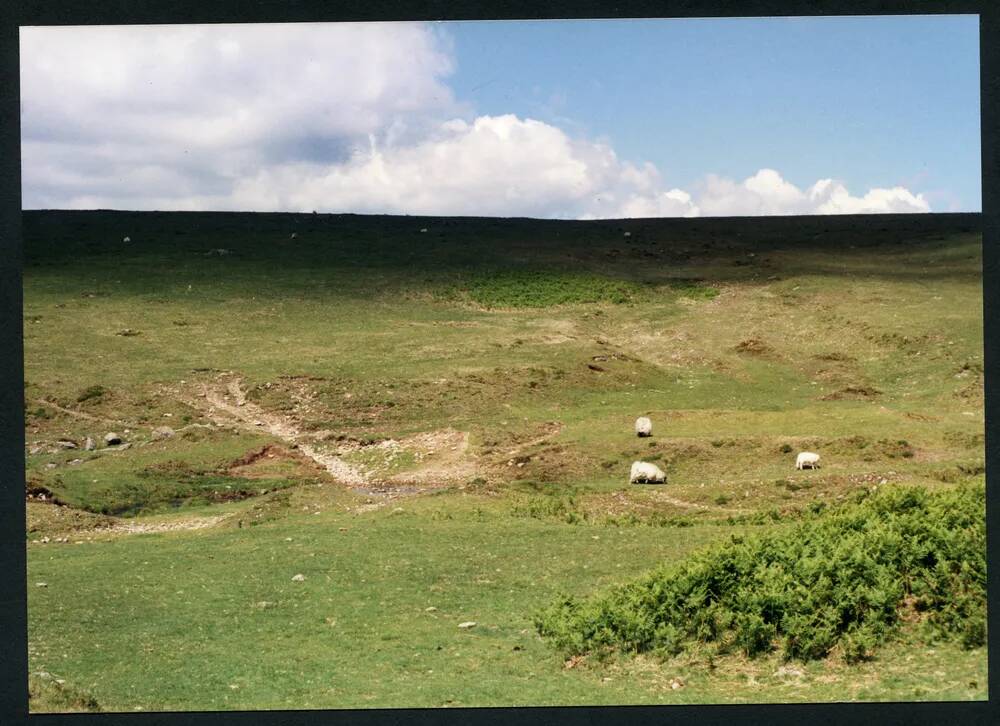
[234,115,696,218]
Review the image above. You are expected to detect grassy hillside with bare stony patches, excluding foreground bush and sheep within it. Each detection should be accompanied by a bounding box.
[24,212,986,710]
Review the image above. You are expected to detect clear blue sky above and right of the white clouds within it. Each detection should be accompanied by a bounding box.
[444,16,981,211]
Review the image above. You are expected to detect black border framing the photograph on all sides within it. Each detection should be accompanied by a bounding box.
[0,0,1000,726]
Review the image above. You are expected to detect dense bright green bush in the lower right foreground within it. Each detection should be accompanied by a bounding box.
[535,484,986,661]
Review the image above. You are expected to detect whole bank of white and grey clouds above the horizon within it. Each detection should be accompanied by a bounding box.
[21,23,930,219]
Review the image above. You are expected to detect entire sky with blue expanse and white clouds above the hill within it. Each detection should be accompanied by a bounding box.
[21,16,981,219]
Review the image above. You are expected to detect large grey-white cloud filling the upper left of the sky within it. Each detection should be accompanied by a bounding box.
[21,23,468,209]
